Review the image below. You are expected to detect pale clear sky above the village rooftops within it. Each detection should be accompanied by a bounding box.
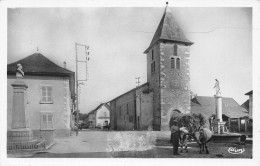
[7,6,252,113]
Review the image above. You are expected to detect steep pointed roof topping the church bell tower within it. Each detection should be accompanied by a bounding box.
[144,7,193,53]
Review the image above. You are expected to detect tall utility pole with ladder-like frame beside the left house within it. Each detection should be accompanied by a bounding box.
[75,43,89,136]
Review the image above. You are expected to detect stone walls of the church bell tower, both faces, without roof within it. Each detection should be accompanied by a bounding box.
[147,42,190,130]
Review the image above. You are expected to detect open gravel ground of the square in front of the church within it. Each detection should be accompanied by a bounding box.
[8,131,252,158]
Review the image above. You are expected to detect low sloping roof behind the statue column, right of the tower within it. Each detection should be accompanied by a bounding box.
[191,96,249,118]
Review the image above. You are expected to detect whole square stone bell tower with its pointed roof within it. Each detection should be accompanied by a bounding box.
[144,3,193,131]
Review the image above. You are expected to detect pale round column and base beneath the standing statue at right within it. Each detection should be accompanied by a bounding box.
[212,95,226,134]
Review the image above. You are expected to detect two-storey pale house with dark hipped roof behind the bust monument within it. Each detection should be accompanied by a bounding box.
[7,53,75,141]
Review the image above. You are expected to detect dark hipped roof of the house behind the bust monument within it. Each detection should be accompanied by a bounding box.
[7,53,75,94]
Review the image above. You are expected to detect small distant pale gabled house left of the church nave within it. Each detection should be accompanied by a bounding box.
[84,103,110,129]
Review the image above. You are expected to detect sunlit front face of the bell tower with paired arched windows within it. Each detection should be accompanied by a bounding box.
[160,43,190,130]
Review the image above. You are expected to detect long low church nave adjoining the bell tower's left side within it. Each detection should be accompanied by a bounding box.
[109,83,153,130]
